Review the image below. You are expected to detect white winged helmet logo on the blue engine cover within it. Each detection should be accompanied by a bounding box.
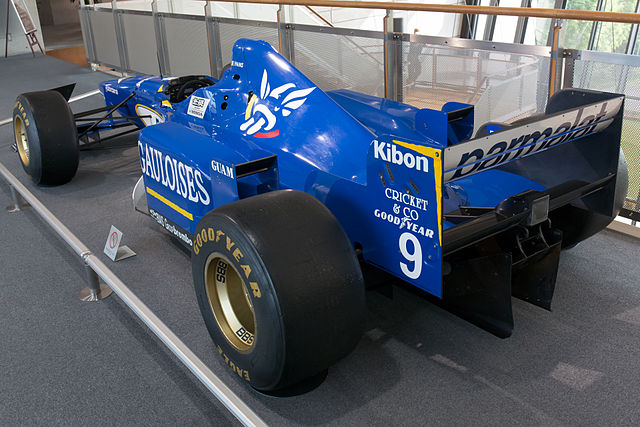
[240,70,315,138]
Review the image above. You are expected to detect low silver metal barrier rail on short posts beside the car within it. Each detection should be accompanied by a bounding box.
[0,163,267,426]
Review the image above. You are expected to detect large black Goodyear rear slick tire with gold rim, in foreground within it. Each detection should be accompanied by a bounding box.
[192,190,365,392]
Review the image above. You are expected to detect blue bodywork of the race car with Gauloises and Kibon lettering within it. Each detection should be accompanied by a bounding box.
[101,40,624,304]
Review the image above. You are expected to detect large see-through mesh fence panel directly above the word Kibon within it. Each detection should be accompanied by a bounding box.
[402,42,549,128]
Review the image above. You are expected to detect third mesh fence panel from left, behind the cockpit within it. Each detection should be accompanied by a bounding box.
[162,17,211,76]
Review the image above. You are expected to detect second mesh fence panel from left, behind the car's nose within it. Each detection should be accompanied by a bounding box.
[120,13,159,74]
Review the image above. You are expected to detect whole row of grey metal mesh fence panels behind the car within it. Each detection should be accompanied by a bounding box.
[83,8,640,221]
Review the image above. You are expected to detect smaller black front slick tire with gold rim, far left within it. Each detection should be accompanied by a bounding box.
[13,90,79,185]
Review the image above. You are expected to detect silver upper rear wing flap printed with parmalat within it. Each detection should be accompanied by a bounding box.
[443,90,624,182]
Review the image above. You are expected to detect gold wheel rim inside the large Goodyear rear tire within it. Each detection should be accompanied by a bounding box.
[204,253,256,351]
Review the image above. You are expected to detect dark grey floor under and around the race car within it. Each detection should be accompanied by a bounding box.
[0,57,640,426]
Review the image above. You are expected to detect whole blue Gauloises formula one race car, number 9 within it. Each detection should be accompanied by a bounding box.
[14,40,627,391]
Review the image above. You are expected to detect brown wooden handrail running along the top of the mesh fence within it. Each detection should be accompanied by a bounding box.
[206,0,640,24]
